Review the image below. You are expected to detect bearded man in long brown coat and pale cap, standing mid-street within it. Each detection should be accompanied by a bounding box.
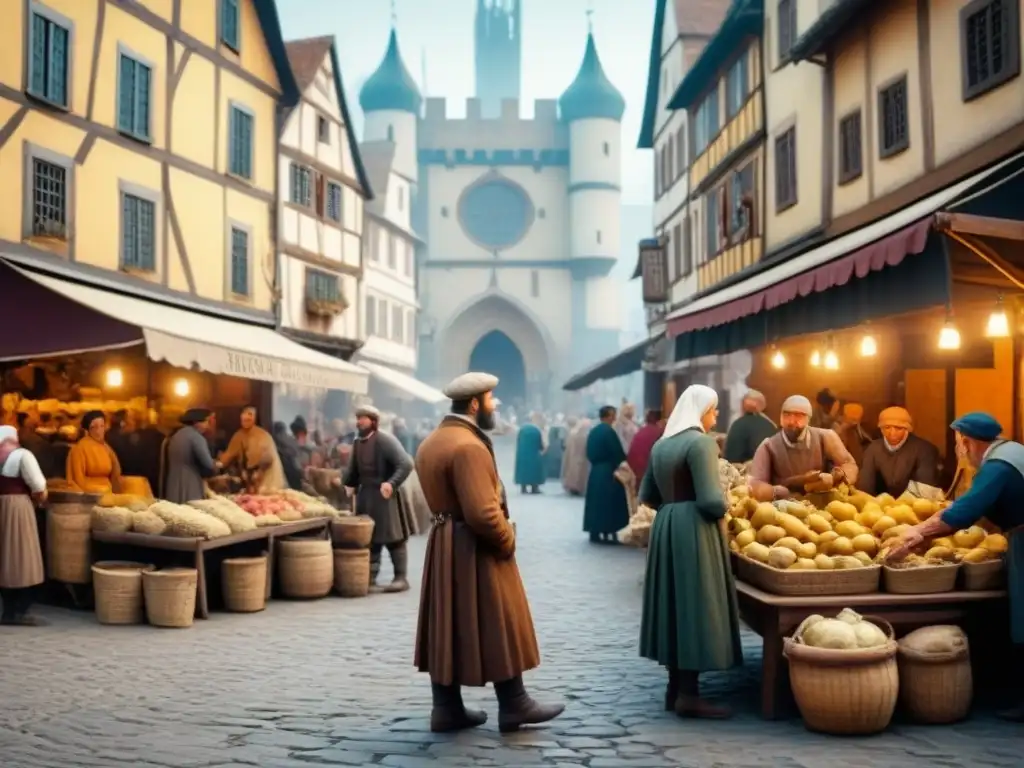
[416,373,564,733]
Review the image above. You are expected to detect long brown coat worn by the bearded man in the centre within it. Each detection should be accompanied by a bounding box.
[416,416,541,686]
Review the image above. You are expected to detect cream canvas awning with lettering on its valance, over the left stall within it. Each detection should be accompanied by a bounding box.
[9,264,370,394]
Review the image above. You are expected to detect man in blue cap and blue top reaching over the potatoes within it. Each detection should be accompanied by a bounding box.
[888,412,1024,723]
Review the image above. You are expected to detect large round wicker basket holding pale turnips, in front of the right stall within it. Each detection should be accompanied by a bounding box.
[783,616,899,735]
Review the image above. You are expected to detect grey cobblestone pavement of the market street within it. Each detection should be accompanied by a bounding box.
[0,438,1021,768]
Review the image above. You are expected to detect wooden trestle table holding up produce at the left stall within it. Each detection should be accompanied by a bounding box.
[92,517,331,618]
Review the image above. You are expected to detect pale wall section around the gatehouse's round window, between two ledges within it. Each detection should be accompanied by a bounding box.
[427,166,569,261]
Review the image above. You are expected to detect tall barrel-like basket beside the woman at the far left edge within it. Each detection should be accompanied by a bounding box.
[46,490,99,584]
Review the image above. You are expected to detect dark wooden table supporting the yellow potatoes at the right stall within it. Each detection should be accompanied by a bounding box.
[736,579,1007,720]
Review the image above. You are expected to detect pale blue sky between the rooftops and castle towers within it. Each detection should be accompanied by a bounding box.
[278,0,654,205]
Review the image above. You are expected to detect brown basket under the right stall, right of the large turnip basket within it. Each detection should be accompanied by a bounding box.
[898,643,974,725]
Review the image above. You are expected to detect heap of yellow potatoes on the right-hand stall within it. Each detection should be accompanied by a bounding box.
[726,485,1008,570]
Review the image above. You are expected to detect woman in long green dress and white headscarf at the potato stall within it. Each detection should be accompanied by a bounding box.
[639,385,742,718]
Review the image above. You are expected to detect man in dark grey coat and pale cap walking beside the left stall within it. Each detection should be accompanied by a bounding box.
[342,406,413,592]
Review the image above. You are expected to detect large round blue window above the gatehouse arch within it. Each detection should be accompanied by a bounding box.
[459,173,536,251]
